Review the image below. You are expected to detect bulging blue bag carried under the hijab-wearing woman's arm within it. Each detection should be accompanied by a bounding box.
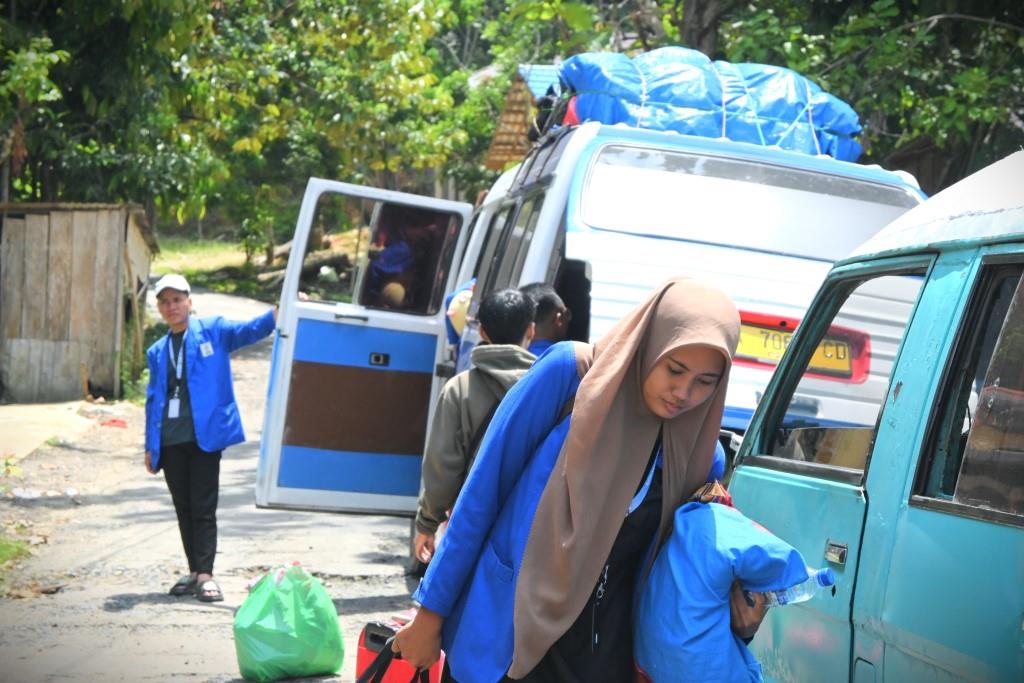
[634,503,807,683]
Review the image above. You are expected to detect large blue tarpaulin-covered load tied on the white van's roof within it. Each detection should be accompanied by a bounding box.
[558,47,861,161]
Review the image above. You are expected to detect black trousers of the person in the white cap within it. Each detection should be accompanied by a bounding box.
[160,441,220,574]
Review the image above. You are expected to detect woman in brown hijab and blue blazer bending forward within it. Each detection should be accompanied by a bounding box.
[392,279,764,683]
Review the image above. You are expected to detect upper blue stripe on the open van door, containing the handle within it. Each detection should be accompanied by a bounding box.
[295,319,437,373]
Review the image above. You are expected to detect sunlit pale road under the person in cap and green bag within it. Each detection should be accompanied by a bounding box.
[0,294,411,683]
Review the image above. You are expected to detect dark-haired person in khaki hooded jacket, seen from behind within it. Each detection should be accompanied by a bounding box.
[413,289,537,563]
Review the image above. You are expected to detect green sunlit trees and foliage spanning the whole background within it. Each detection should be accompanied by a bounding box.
[0,0,1024,231]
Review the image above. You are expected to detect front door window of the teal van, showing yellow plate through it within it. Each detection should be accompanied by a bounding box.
[761,272,923,479]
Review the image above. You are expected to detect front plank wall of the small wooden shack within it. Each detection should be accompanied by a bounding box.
[0,209,125,402]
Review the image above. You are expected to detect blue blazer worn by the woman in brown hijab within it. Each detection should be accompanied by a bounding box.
[413,342,725,683]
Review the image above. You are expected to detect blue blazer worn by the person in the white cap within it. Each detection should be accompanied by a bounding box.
[145,310,274,468]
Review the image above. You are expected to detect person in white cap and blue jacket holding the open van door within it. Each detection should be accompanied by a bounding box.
[145,274,276,602]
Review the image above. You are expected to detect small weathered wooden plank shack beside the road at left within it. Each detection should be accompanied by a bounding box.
[0,204,157,402]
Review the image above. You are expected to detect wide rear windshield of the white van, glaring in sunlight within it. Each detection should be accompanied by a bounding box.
[581,145,918,261]
